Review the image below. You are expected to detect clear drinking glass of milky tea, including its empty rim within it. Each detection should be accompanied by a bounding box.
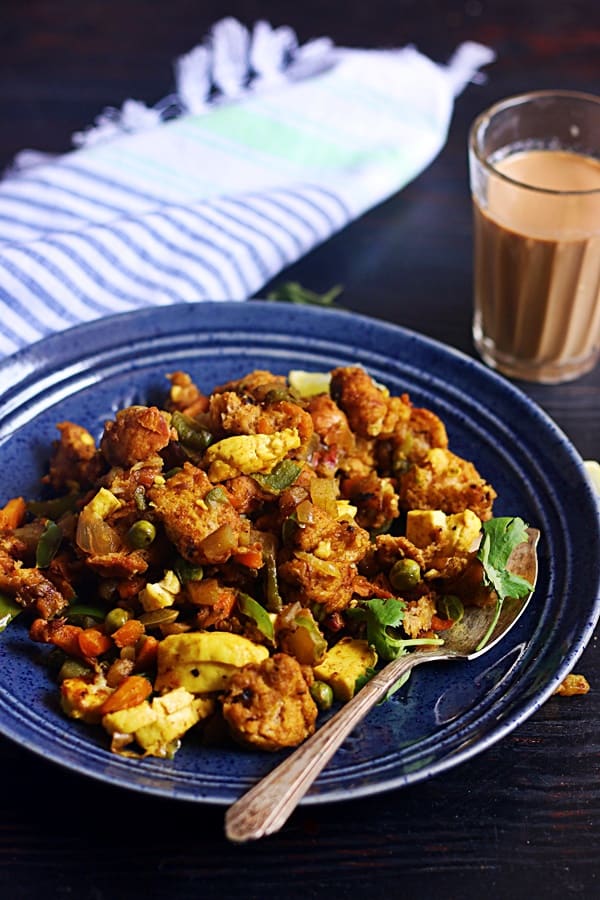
[469,91,600,383]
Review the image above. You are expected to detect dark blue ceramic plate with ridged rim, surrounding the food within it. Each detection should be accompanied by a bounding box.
[0,302,600,803]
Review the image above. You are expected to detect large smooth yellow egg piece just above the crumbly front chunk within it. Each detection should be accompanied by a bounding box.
[155,631,269,694]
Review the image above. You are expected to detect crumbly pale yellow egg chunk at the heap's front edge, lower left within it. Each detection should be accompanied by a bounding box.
[102,688,215,759]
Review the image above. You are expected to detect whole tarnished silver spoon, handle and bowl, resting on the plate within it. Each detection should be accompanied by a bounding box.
[225,528,540,842]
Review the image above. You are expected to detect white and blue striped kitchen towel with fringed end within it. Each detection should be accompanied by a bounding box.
[0,19,493,357]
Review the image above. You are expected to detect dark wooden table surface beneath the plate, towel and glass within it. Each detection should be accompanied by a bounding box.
[0,0,600,900]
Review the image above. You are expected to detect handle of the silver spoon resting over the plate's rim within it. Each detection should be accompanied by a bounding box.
[225,650,452,842]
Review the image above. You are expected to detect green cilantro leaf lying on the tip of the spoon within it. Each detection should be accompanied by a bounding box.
[477,516,532,601]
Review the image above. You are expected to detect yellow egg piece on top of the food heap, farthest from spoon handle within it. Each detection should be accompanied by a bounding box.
[204,428,300,482]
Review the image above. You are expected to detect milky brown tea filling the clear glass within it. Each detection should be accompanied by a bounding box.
[473,149,600,381]
